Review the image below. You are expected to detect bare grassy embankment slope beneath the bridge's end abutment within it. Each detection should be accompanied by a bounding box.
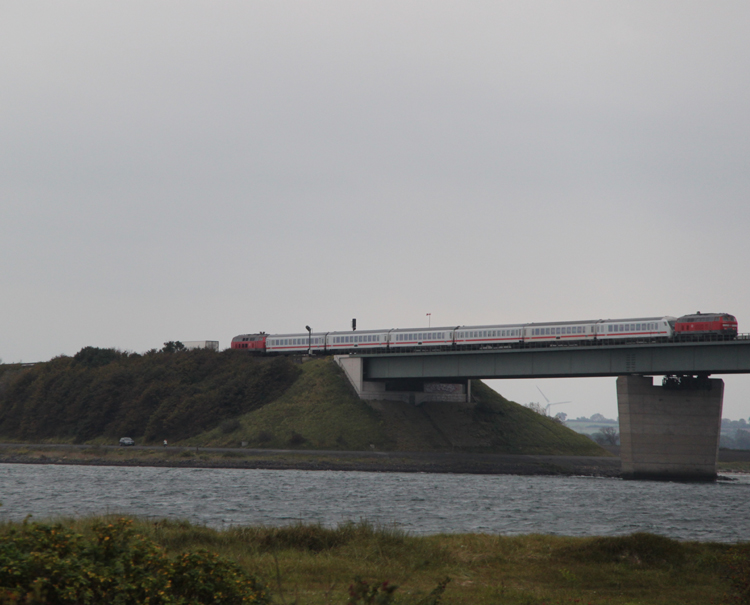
[184,359,609,456]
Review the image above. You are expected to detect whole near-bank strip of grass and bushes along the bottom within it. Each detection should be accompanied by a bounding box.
[0,518,750,605]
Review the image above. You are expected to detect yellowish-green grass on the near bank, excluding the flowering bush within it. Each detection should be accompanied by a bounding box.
[0,518,748,605]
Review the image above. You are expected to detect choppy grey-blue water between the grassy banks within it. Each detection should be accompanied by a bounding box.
[0,464,750,542]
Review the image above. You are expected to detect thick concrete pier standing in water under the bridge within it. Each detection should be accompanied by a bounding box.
[617,376,724,481]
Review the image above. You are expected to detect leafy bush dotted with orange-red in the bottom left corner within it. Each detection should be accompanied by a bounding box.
[0,519,270,605]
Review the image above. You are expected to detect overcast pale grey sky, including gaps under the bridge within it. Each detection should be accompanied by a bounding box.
[0,0,750,418]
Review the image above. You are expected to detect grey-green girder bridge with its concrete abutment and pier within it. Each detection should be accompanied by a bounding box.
[337,335,750,479]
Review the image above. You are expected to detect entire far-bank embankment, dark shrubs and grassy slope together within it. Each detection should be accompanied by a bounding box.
[0,347,606,456]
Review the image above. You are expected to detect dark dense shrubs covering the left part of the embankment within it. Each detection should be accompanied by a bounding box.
[0,347,300,443]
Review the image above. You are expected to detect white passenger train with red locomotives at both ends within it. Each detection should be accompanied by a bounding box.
[231,312,738,355]
